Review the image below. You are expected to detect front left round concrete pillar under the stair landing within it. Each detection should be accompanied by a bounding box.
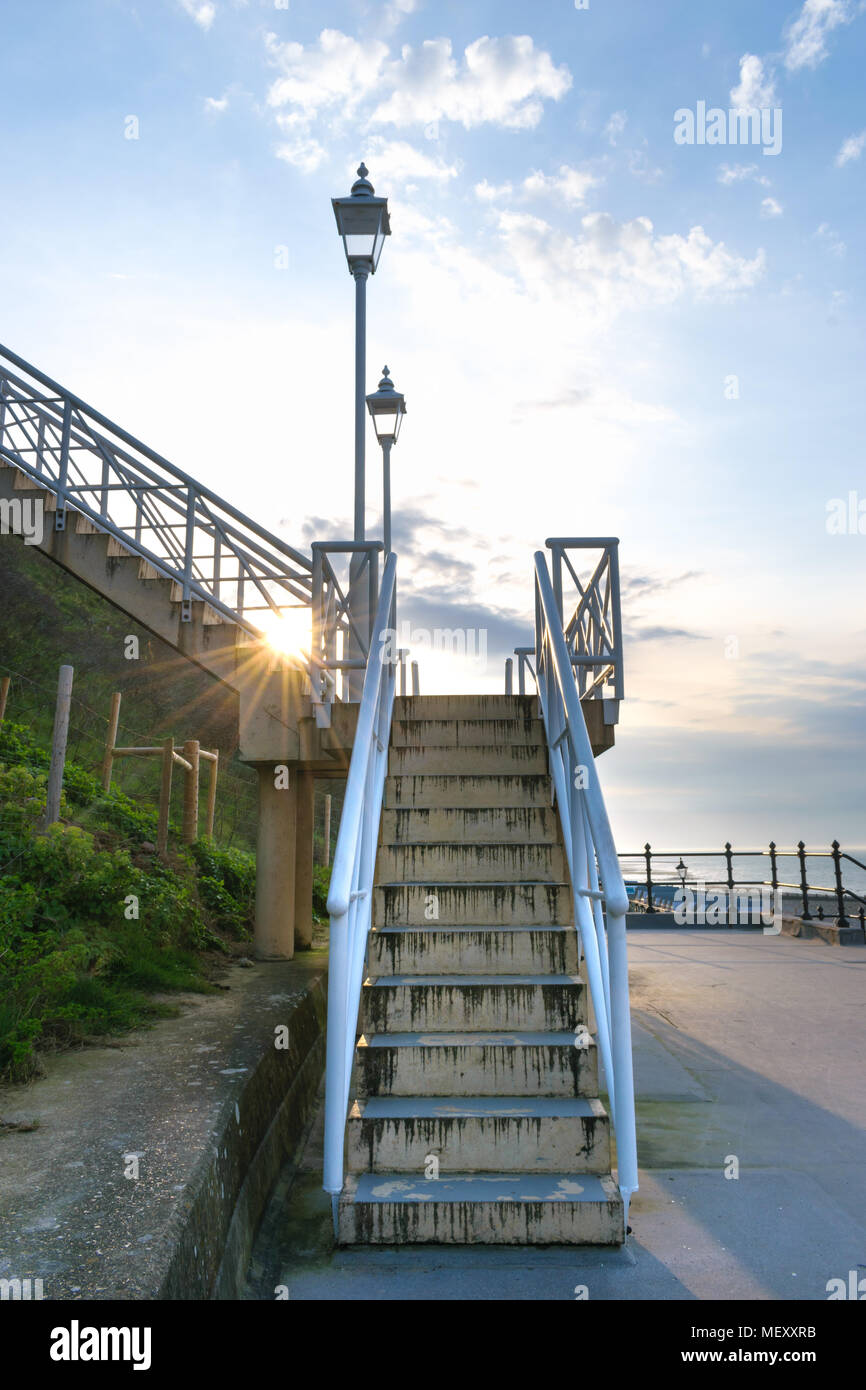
[254,763,299,960]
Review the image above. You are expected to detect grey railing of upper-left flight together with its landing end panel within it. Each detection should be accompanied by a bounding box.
[0,346,403,726]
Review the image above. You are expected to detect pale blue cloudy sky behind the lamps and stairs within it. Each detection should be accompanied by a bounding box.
[0,0,866,851]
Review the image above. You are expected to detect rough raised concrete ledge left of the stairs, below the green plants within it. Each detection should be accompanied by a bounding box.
[0,952,327,1300]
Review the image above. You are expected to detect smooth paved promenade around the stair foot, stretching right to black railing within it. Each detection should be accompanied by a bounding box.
[246,930,866,1300]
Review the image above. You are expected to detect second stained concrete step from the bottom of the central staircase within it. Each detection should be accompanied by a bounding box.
[348,1095,610,1177]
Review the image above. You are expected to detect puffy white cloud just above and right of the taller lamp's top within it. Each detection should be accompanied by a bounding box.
[371,35,571,129]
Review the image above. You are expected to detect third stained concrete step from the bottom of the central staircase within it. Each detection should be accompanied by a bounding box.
[354,1031,598,1098]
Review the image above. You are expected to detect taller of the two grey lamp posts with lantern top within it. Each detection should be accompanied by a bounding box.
[331,164,391,699]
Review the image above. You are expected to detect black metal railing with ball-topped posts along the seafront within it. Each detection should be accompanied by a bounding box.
[619,840,866,927]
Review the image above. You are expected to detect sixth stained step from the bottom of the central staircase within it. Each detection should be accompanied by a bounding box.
[373,883,574,927]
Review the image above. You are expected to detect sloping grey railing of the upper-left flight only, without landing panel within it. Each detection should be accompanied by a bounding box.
[0,346,313,637]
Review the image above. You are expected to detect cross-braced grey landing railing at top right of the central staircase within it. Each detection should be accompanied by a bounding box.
[505,537,623,724]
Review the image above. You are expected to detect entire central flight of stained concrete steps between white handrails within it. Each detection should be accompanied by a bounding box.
[339,695,624,1245]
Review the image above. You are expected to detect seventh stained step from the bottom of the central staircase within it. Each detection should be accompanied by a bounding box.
[375,842,567,884]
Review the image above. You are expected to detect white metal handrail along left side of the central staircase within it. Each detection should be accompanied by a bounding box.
[322,553,398,1229]
